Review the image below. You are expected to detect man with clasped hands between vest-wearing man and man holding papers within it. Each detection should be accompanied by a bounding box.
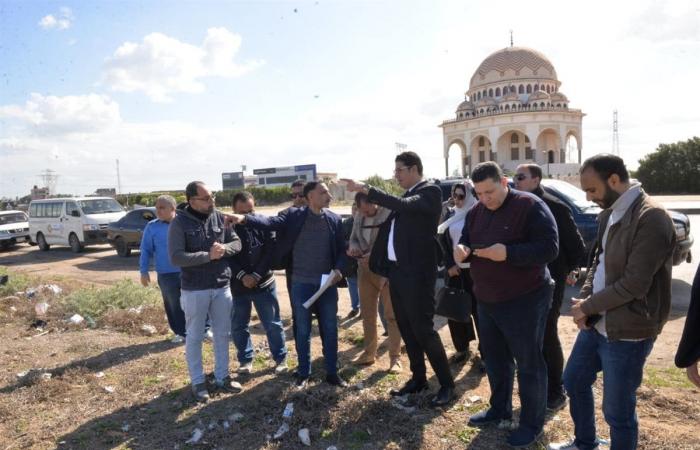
[231,191,287,374]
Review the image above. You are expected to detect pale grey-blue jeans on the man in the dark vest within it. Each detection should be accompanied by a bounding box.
[180,286,232,385]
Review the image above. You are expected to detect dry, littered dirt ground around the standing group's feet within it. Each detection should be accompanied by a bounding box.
[0,245,700,450]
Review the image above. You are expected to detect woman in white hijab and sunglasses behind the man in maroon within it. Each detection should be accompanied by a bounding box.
[438,182,483,370]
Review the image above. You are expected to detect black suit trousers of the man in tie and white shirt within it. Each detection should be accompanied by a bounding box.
[389,266,454,387]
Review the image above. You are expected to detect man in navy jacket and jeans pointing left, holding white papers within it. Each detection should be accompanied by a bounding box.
[229,181,347,388]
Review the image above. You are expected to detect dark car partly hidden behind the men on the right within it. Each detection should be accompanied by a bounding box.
[440,179,694,267]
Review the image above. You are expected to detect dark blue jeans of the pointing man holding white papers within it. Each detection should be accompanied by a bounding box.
[292,281,338,377]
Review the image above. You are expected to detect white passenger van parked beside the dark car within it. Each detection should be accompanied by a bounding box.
[29,197,126,253]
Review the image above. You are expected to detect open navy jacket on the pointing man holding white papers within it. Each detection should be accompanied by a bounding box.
[245,206,348,273]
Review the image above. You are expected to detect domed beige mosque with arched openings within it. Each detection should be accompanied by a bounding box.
[440,43,584,179]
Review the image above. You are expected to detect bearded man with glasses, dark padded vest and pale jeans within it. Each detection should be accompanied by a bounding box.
[168,181,242,402]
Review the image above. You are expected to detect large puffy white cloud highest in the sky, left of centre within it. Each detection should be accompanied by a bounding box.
[102,28,263,102]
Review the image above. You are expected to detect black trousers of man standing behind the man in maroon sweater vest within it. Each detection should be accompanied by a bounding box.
[542,275,566,399]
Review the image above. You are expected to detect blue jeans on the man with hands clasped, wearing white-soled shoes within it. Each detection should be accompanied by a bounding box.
[231,282,287,364]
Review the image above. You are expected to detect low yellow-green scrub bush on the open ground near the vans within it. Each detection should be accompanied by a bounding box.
[63,279,162,320]
